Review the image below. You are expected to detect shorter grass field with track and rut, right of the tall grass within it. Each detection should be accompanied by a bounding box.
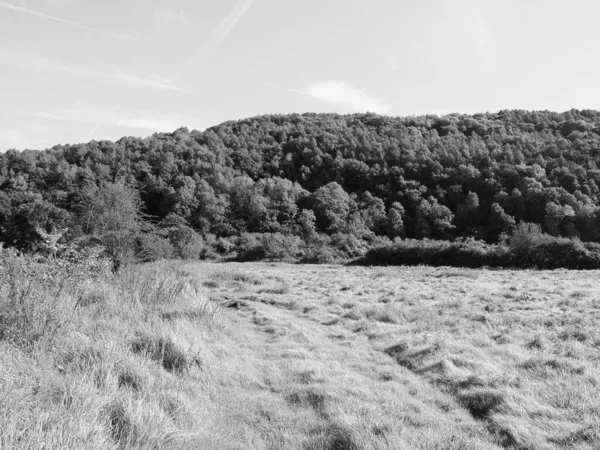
[186,264,600,450]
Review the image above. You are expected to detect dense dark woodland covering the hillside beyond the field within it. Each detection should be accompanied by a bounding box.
[0,110,600,259]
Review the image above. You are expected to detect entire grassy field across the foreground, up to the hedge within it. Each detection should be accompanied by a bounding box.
[0,255,600,450]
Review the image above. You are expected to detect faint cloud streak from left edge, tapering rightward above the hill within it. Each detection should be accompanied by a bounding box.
[0,49,192,94]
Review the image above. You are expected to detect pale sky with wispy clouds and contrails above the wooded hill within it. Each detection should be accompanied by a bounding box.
[0,0,600,151]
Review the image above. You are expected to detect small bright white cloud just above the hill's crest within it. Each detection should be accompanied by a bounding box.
[304,81,390,114]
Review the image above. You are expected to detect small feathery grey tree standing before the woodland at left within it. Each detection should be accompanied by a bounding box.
[77,181,152,271]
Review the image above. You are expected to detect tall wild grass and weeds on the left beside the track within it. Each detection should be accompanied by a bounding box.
[0,249,220,450]
